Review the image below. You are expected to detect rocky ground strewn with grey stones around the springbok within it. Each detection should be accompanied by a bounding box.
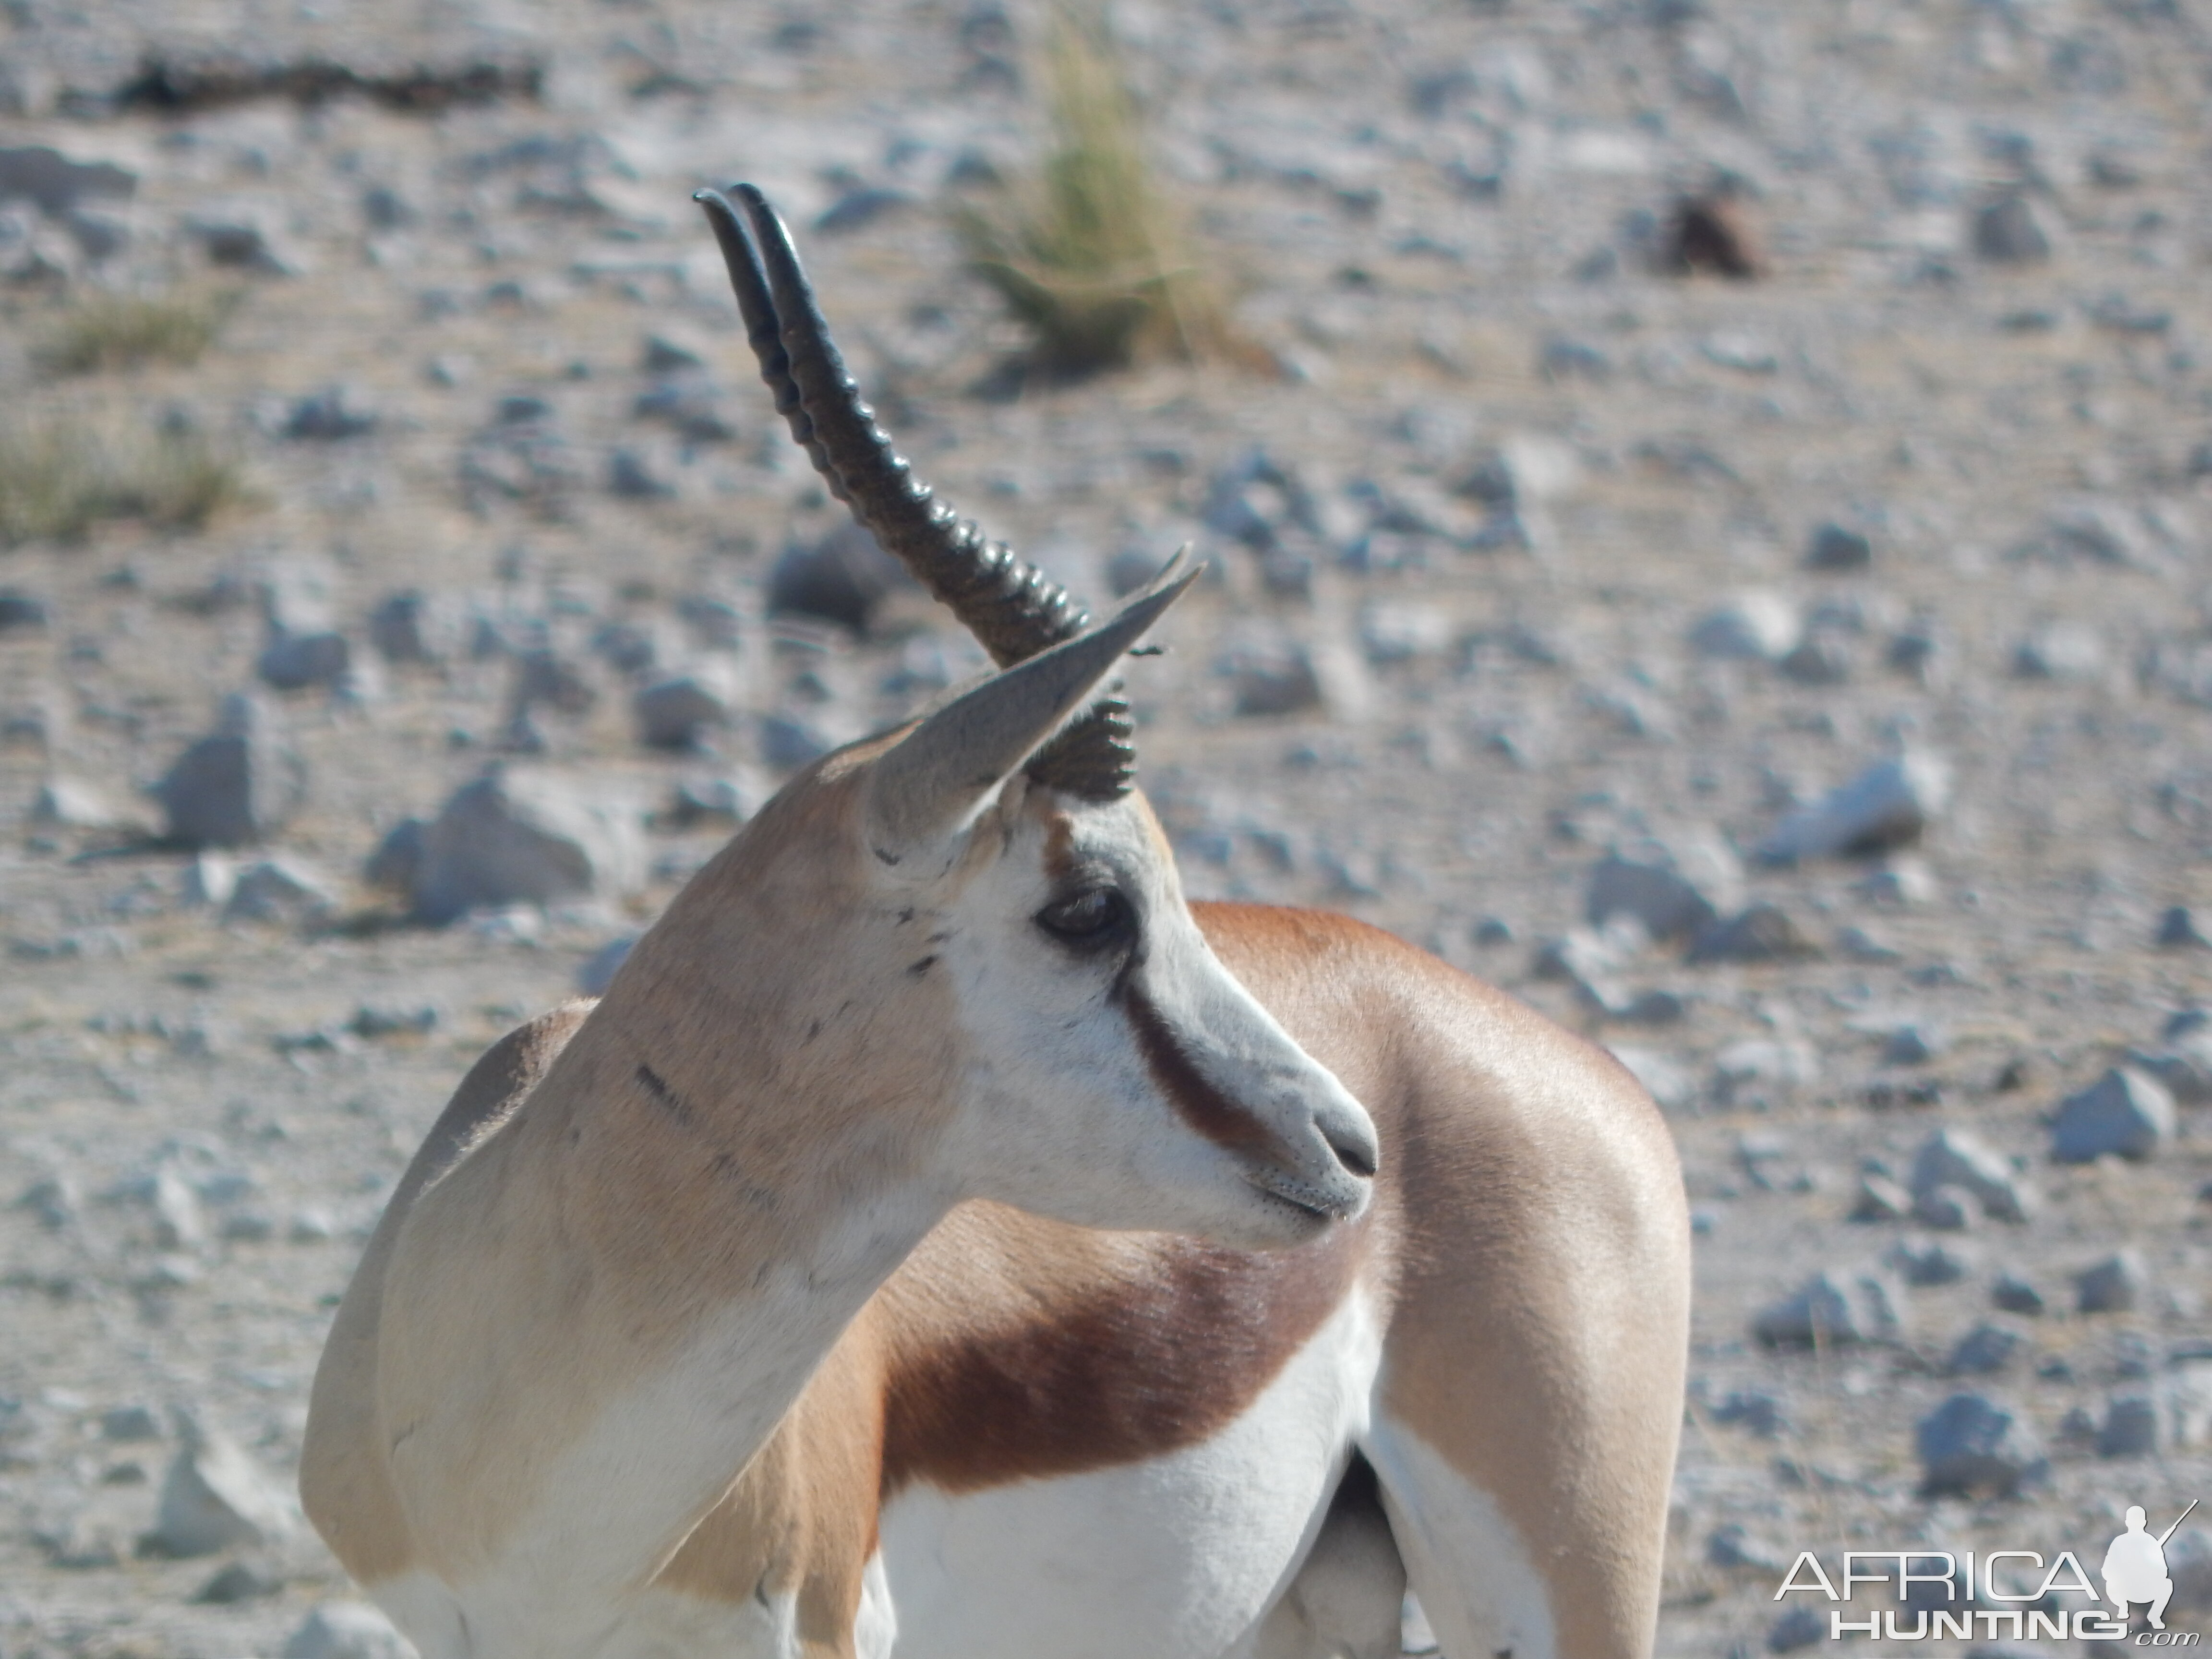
[0,0,2212,1659]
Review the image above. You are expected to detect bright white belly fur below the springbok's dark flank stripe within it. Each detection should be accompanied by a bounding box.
[883,1296,1382,1659]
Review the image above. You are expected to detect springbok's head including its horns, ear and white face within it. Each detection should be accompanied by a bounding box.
[697,183,1376,1248]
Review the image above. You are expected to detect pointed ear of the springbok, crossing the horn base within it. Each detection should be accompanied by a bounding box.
[867,553,1199,865]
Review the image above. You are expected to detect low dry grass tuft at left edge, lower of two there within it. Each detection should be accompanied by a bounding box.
[0,421,248,546]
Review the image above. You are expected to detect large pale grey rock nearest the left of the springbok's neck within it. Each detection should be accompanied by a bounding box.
[414,765,646,925]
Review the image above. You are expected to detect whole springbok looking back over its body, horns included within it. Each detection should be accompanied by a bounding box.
[301,186,1688,1659]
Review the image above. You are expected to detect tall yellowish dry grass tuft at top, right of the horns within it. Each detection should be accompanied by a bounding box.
[958,4,1274,374]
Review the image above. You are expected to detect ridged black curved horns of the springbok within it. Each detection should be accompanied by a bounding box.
[692,183,1137,798]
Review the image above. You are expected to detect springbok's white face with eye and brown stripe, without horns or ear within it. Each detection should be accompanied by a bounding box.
[916,779,1376,1250]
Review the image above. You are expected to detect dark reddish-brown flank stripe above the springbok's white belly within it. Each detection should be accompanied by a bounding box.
[883,1227,1360,1500]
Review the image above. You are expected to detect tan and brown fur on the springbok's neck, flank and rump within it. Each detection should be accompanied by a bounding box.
[303,750,1688,1659]
